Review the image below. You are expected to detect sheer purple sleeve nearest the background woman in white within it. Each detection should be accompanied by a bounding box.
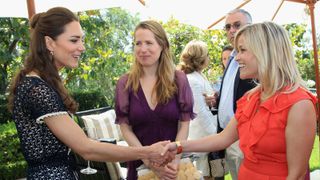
[175,70,195,121]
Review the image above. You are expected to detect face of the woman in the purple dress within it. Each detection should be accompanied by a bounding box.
[134,28,162,67]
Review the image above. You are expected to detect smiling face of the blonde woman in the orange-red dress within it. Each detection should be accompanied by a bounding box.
[236,35,259,79]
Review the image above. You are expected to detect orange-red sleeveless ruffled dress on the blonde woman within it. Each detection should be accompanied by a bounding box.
[235,88,317,180]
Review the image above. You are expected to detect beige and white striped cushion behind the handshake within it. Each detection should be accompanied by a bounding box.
[81,109,123,141]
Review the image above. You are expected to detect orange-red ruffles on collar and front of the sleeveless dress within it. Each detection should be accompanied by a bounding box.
[235,88,317,162]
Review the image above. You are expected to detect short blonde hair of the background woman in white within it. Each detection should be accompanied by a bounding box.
[179,40,209,74]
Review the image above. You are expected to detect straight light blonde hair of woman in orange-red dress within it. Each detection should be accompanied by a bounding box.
[235,22,304,99]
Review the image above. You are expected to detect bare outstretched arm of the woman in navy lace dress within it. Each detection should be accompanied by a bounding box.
[44,115,170,161]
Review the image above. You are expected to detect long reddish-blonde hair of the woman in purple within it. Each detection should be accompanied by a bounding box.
[126,20,177,104]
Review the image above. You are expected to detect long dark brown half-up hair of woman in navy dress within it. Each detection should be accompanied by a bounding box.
[9,7,79,113]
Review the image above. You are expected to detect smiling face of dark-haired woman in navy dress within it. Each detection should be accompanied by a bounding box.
[45,21,85,69]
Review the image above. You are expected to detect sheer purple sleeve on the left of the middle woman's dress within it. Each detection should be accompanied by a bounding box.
[115,74,129,124]
